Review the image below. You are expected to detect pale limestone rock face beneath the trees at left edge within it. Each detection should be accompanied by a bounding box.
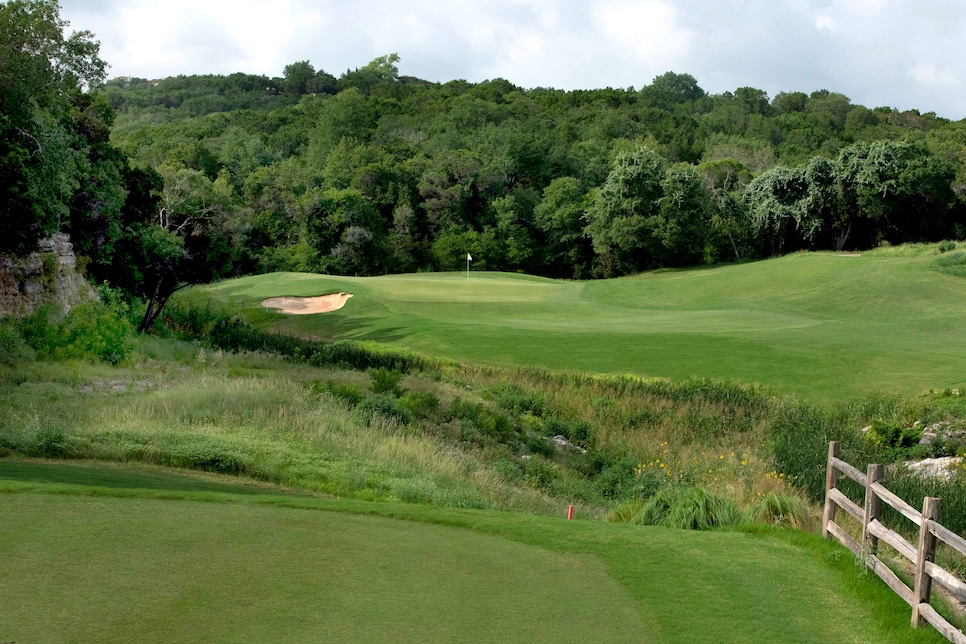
[0,233,97,316]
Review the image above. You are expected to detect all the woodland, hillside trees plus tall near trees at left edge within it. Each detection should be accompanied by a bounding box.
[7,0,966,326]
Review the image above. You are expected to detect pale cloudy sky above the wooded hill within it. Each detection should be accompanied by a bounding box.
[61,0,966,120]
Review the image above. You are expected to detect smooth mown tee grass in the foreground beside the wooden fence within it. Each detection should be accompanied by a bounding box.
[0,460,943,642]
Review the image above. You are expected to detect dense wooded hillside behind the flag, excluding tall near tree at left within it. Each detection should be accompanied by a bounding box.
[103,55,966,278]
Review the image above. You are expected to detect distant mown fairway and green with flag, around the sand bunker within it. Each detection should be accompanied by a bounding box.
[210,250,966,401]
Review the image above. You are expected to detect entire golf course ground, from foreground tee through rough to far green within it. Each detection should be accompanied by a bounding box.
[0,246,966,643]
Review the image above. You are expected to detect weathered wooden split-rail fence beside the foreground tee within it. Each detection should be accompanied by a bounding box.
[822,441,966,644]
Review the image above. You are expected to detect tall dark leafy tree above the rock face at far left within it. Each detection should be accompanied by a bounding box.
[0,0,106,252]
